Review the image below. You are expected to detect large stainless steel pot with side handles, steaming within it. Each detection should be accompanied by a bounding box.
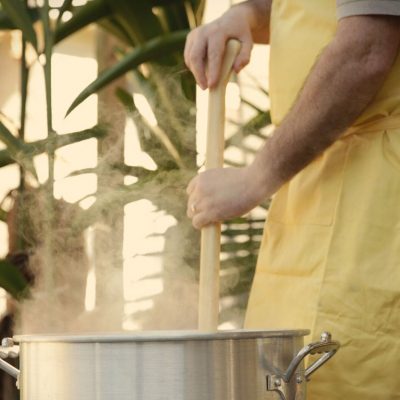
[0,330,339,400]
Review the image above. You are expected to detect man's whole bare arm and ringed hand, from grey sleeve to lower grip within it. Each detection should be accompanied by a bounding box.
[188,16,400,228]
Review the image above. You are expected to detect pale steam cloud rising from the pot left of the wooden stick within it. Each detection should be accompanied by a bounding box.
[16,68,203,334]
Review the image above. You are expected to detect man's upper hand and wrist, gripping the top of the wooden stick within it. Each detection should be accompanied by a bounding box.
[184,0,271,90]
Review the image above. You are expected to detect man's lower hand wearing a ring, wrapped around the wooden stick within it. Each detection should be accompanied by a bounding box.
[187,166,267,229]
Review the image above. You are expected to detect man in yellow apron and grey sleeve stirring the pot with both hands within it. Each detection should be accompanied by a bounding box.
[185,0,400,400]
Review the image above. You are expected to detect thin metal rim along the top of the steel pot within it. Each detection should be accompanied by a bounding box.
[14,329,310,343]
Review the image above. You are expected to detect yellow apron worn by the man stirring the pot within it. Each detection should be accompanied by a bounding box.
[245,0,400,400]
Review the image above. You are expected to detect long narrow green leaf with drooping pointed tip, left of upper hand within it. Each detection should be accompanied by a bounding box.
[66,30,188,115]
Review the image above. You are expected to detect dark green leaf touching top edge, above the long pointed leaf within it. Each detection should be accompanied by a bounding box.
[54,0,111,43]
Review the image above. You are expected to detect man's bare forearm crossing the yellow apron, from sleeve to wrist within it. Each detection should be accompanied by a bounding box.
[254,17,400,195]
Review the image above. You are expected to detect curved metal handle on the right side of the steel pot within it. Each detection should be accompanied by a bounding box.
[282,332,340,383]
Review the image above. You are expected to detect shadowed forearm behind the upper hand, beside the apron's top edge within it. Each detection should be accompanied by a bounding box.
[231,0,272,44]
